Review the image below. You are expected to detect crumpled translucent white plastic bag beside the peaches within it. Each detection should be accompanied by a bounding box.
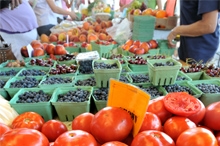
[106,18,132,44]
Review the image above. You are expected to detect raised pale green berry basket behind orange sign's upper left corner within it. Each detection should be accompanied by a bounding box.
[92,60,122,87]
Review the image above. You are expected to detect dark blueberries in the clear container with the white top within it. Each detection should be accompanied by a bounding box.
[79,60,93,74]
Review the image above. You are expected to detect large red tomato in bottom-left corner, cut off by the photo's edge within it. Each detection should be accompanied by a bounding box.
[0,128,49,146]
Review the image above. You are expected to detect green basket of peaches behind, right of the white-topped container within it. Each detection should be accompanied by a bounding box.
[91,42,114,58]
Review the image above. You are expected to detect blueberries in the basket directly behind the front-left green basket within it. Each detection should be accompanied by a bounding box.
[10,77,40,88]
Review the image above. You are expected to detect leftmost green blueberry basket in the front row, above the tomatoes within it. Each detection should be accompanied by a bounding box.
[9,88,55,121]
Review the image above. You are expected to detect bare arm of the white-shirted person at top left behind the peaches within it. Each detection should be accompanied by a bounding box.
[46,0,76,19]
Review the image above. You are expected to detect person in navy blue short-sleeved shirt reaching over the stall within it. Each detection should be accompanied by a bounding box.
[167,0,220,63]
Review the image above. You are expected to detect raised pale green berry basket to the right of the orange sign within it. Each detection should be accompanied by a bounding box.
[148,58,182,86]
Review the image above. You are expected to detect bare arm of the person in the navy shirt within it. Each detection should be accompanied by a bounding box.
[167,10,218,46]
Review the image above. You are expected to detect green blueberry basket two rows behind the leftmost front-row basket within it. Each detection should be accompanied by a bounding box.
[16,66,50,77]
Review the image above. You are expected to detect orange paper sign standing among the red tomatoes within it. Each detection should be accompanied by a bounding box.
[107,79,150,136]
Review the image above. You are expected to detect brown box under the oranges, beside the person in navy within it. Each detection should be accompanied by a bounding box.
[155,16,179,30]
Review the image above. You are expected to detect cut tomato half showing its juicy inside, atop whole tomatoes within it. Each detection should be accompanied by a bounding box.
[163,92,201,117]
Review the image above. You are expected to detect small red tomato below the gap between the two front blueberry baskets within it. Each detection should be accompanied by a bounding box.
[41,120,68,142]
